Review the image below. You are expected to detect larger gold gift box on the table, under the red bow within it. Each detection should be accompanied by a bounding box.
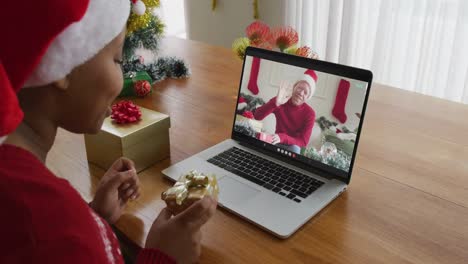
[85,107,170,172]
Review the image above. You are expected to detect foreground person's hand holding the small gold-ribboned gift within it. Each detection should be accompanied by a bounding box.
[145,197,218,264]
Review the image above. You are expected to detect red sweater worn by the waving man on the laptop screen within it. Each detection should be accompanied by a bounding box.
[254,96,315,147]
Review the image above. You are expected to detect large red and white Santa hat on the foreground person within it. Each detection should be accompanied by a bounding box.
[0,0,130,144]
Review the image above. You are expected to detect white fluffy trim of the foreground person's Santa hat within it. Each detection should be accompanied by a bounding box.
[24,0,130,87]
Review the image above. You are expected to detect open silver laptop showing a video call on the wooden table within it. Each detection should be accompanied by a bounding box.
[162,47,372,238]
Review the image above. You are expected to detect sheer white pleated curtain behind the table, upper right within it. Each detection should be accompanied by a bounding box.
[284,0,468,103]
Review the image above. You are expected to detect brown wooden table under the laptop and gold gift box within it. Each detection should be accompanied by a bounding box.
[48,38,468,263]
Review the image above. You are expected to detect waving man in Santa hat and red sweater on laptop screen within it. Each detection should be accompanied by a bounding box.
[254,70,317,154]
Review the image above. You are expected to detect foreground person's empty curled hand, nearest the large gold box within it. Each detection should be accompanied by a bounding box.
[90,158,140,224]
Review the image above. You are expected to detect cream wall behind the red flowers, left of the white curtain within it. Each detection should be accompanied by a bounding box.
[184,0,286,48]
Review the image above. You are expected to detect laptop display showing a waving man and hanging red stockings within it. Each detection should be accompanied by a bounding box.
[234,48,371,182]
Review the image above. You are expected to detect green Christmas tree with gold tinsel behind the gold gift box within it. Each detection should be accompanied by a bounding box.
[122,0,190,83]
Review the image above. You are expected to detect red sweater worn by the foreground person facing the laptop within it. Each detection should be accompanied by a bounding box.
[0,145,175,264]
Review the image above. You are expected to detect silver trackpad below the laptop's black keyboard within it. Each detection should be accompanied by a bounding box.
[218,176,260,204]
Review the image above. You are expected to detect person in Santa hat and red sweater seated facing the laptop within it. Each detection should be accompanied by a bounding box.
[0,0,216,263]
